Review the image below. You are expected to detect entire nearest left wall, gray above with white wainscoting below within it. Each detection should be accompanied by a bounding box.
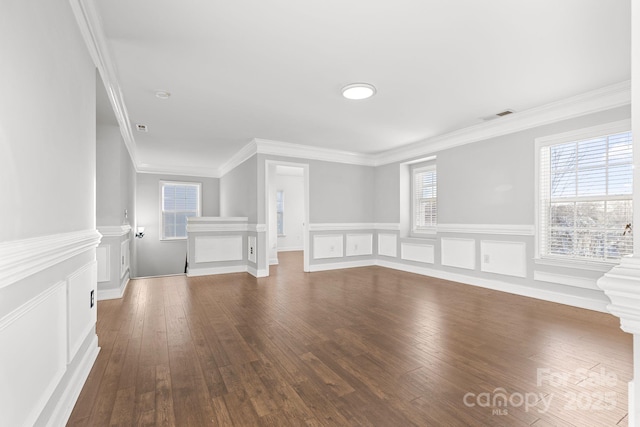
[0,0,99,426]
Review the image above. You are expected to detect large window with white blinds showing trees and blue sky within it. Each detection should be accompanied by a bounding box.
[536,121,633,262]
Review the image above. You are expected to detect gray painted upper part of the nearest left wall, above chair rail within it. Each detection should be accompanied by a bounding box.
[0,1,96,242]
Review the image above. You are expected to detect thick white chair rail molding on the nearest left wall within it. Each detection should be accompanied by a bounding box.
[0,230,102,289]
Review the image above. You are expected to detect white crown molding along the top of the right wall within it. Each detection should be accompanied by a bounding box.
[374,80,631,166]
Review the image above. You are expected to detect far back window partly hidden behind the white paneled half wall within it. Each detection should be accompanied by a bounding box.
[160,181,201,240]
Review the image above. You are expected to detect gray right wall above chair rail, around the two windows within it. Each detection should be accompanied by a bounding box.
[374,107,631,224]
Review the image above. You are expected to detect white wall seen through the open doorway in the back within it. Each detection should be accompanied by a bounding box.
[274,169,304,251]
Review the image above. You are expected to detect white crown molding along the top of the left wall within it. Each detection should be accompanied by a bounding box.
[69,0,138,171]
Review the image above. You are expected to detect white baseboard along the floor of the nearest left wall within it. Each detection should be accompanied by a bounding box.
[46,335,100,427]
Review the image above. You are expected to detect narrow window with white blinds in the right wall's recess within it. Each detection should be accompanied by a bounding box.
[411,164,438,233]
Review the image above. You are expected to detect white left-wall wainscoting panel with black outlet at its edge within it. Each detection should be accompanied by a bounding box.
[67,262,97,363]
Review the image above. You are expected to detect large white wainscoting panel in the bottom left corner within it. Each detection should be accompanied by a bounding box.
[0,282,67,426]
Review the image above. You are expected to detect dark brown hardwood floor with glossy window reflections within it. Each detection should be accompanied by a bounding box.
[69,252,632,427]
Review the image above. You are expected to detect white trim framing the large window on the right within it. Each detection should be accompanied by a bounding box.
[534,119,633,271]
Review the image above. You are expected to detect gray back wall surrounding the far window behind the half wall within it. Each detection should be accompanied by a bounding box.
[135,173,220,277]
